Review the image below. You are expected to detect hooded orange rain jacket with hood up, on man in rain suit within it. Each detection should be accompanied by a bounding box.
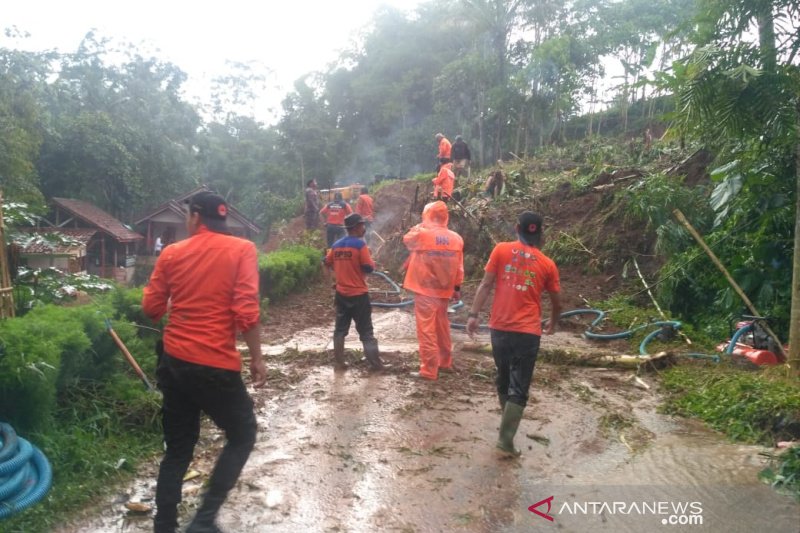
[403,201,464,298]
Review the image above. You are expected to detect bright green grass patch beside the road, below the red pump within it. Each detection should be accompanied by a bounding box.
[663,364,800,446]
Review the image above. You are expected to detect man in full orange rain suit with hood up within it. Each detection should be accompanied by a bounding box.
[403,201,464,379]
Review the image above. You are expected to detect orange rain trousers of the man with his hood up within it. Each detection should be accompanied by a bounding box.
[414,293,453,379]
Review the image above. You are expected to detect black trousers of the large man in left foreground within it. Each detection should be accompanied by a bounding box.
[155,353,256,531]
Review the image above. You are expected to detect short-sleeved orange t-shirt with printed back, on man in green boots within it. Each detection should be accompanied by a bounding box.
[484,241,561,335]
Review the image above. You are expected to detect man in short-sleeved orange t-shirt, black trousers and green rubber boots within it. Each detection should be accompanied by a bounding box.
[467,211,561,456]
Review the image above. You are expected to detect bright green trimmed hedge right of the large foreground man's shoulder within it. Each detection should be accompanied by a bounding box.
[258,246,322,302]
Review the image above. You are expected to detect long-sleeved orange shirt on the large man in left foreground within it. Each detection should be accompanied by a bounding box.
[142,226,260,370]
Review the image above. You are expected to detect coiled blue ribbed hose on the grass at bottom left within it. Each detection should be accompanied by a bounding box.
[0,422,53,519]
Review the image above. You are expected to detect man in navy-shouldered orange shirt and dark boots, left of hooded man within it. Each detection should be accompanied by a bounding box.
[324,213,383,370]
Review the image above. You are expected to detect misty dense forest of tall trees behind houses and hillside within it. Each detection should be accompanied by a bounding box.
[0,0,800,358]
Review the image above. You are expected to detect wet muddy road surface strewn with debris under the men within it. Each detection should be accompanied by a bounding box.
[60,310,800,533]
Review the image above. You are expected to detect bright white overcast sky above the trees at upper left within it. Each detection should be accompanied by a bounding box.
[0,0,422,123]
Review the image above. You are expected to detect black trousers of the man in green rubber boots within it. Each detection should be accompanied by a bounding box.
[491,329,541,407]
